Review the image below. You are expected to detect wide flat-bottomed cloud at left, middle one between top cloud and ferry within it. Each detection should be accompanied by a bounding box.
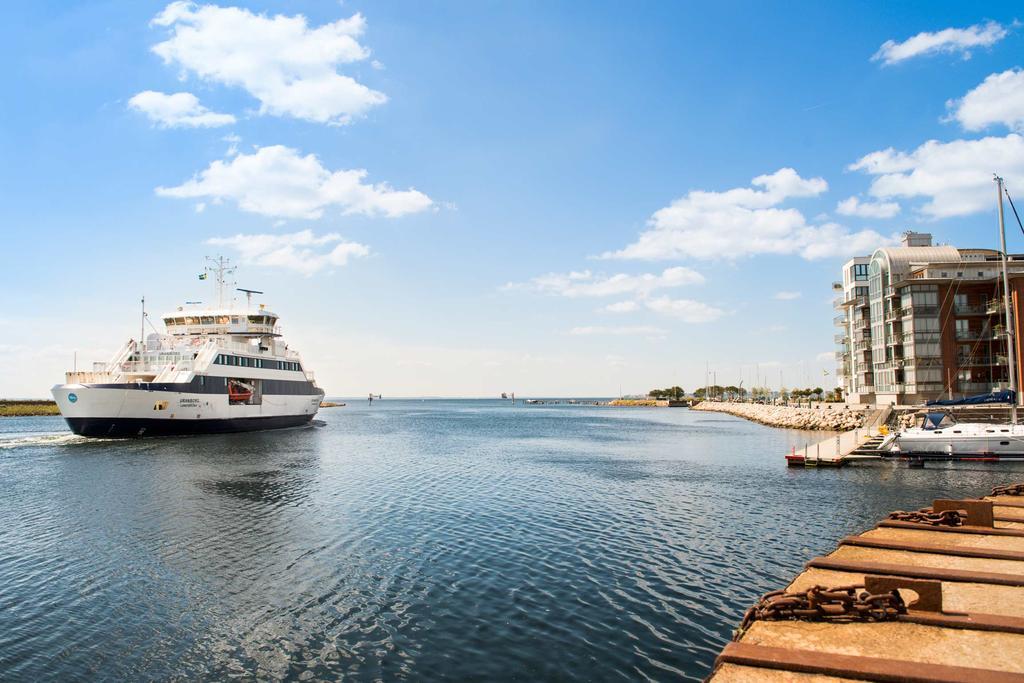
[157,144,433,218]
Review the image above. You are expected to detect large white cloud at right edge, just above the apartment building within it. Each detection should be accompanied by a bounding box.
[850,133,1024,219]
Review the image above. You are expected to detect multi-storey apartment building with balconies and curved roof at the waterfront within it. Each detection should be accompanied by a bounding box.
[833,232,1024,404]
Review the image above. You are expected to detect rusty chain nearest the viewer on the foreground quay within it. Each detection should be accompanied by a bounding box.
[733,585,906,640]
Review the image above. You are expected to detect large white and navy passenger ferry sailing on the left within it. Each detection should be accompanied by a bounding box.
[51,258,324,438]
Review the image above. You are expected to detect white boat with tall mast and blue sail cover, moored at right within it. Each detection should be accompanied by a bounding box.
[891,176,1024,459]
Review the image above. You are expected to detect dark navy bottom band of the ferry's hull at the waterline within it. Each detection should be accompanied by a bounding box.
[65,414,313,438]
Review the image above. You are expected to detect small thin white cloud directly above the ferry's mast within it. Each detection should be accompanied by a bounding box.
[206,230,370,275]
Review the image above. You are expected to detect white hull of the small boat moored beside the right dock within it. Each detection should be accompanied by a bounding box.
[894,423,1024,458]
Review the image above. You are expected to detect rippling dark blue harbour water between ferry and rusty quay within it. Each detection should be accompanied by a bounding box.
[0,401,1021,681]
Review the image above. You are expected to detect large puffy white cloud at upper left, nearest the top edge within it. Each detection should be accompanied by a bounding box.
[153,1,387,124]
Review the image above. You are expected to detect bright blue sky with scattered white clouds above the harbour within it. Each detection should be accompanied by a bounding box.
[0,0,1024,396]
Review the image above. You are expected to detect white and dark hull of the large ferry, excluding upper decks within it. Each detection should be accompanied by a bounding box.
[52,384,324,437]
